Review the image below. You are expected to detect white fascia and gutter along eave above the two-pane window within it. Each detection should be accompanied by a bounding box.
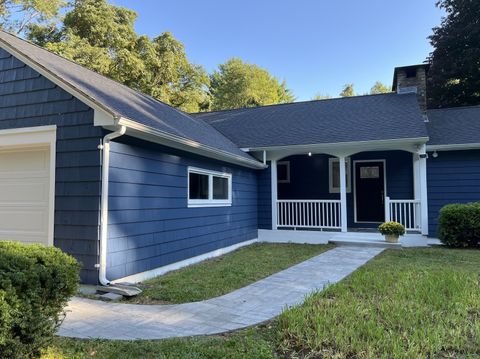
[115,117,267,169]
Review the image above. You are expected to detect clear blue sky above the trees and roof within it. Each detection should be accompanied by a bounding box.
[110,0,443,100]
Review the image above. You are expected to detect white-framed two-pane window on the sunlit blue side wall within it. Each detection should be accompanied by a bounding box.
[188,167,232,207]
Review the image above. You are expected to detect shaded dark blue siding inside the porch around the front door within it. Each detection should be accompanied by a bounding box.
[258,151,413,229]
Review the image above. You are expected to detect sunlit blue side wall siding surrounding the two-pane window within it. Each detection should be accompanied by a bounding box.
[107,136,258,279]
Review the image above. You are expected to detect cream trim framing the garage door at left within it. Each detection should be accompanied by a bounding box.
[0,125,57,246]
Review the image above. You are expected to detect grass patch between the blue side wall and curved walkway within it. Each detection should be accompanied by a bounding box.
[128,243,333,304]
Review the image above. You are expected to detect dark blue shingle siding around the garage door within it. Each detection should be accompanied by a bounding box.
[0,49,102,283]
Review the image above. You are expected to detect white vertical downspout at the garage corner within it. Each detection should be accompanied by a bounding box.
[98,126,127,286]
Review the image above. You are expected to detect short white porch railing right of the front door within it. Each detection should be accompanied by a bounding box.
[385,197,422,231]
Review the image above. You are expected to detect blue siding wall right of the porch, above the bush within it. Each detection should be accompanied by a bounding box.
[427,150,480,236]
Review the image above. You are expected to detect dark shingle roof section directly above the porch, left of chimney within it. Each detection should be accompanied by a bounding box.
[195,93,428,148]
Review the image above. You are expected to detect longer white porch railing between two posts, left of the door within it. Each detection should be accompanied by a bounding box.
[277,199,341,229]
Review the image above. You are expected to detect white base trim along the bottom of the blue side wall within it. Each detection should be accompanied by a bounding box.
[112,238,258,283]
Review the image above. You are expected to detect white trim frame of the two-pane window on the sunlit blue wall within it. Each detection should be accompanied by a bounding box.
[187,166,232,208]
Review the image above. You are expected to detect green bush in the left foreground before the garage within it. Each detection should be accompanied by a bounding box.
[0,242,80,358]
